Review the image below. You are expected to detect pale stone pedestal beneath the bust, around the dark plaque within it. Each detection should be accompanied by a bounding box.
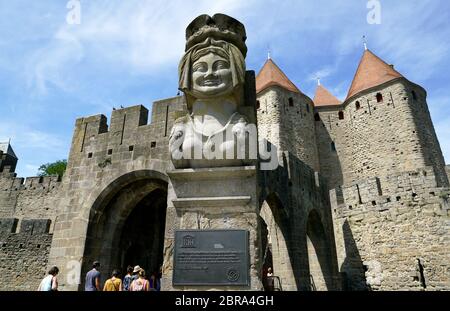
[163,166,263,290]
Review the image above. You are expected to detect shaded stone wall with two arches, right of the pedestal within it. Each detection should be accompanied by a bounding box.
[259,152,340,291]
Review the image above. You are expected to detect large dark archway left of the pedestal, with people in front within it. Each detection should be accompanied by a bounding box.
[81,173,167,286]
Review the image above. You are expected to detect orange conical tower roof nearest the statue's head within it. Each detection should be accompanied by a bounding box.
[256,58,301,93]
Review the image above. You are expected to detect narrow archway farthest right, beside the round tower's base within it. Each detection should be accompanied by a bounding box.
[306,210,333,291]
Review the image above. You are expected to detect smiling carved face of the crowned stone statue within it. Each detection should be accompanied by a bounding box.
[192,52,233,99]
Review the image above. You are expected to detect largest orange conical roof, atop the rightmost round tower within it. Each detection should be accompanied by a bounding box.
[347,50,403,99]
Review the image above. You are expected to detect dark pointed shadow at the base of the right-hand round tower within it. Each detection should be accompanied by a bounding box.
[340,220,371,291]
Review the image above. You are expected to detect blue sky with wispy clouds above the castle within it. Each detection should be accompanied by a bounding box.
[0,0,450,177]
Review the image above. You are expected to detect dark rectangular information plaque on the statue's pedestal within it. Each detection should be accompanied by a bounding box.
[172,230,250,286]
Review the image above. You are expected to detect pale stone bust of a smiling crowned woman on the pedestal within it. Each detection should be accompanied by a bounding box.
[169,14,257,168]
